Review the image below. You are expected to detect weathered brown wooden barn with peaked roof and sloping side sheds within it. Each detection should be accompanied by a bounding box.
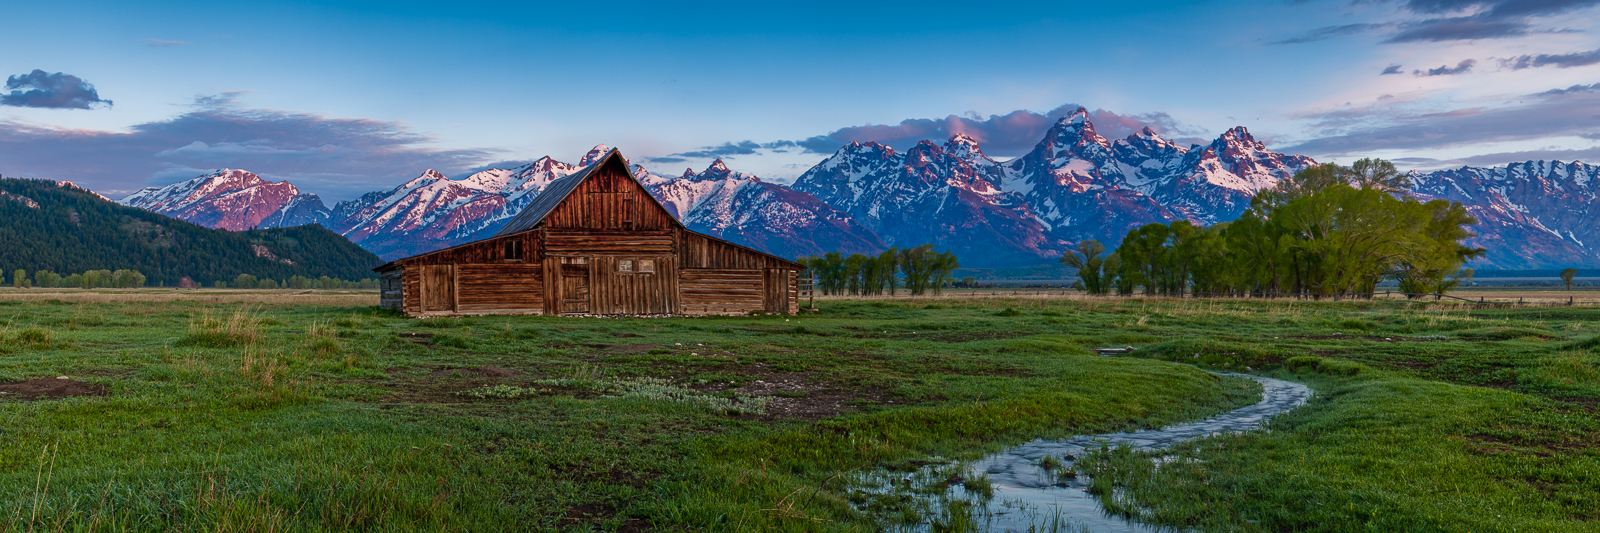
[373,149,803,317]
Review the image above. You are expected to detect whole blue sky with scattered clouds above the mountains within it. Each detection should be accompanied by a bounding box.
[0,0,1600,200]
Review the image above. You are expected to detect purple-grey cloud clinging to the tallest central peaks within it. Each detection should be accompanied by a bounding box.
[774,104,1208,157]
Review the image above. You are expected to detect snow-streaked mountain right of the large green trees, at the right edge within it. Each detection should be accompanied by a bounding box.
[1411,156,1600,269]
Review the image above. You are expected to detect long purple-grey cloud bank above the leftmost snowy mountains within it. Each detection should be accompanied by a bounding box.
[0,93,499,200]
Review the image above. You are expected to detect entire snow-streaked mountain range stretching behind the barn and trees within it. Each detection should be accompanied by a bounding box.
[120,109,1600,269]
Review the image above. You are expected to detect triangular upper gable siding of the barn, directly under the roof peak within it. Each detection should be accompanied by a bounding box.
[541,165,675,230]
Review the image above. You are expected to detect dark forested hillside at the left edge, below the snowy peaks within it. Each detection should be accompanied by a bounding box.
[0,178,382,287]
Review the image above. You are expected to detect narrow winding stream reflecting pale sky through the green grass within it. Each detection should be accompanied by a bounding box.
[858,376,1312,533]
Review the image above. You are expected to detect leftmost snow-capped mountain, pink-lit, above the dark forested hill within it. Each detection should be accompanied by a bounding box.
[118,168,328,230]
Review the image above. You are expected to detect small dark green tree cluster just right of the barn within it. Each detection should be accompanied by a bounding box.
[797,245,962,296]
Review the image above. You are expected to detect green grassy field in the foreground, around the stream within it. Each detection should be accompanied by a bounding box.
[0,290,1600,531]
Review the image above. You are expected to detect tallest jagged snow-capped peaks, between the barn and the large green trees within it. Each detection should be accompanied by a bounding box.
[795,109,1315,266]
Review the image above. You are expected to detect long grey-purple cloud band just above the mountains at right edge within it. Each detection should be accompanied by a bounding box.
[1283,85,1600,157]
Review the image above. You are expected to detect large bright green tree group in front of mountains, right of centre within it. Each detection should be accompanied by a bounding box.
[1061,158,1483,298]
